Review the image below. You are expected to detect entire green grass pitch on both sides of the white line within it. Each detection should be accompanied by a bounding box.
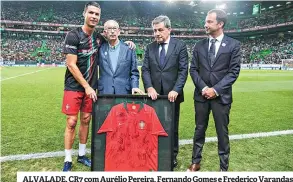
[1,67,293,181]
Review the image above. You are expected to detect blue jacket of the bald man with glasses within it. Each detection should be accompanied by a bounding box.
[98,42,139,94]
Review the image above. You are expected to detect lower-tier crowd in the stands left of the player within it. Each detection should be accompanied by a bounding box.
[1,32,64,63]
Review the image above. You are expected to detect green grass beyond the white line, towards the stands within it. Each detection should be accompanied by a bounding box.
[1,67,293,156]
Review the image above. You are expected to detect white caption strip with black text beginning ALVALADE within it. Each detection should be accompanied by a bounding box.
[17,172,293,182]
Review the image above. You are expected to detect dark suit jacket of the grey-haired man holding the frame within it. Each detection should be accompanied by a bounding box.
[141,38,188,102]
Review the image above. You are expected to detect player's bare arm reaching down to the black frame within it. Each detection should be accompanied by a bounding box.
[66,54,97,101]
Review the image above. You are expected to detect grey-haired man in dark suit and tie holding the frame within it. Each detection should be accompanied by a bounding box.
[141,15,188,167]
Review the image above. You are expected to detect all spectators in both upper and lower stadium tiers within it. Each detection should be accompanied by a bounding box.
[1,1,293,64]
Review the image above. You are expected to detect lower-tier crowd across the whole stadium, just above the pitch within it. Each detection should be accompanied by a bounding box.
[1,32,293,64]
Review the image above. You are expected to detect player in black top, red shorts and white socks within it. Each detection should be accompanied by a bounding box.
[62,2,105,171]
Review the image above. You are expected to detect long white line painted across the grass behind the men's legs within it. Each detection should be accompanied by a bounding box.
[0,130,293,162]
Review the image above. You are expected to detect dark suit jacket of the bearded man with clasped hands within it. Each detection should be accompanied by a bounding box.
[190,35,240,104]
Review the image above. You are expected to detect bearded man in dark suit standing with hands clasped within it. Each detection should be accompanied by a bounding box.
[188,9,240,171]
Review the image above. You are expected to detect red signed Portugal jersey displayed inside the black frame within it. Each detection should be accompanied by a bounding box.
[98,103,168,171]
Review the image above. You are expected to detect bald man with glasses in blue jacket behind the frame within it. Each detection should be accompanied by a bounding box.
[98,20,144,95]
